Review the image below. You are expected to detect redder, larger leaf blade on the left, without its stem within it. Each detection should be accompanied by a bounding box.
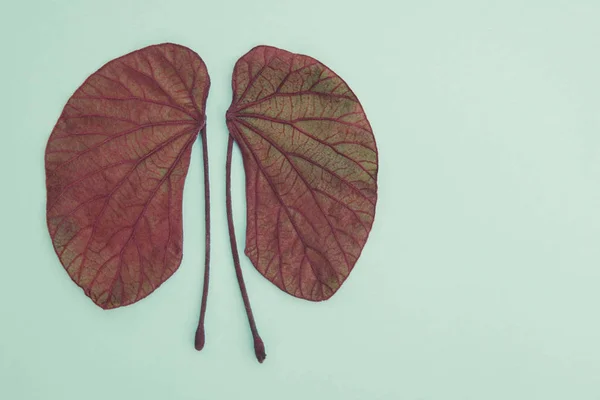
[45,44,210,309]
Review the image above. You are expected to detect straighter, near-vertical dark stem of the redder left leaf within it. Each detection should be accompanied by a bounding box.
[194,124,210,351]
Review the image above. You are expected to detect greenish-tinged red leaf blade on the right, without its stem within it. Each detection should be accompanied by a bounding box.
[227,46,378,301]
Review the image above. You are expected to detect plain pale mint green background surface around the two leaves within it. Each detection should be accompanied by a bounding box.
[0,0,600,400]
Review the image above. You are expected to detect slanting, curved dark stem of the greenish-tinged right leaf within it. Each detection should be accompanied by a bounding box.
[225,135,267,363]
